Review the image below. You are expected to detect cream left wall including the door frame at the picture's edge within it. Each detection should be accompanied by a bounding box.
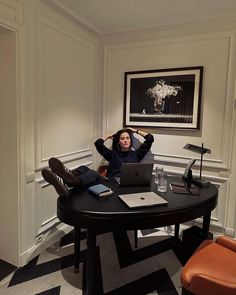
[0,0,101,265]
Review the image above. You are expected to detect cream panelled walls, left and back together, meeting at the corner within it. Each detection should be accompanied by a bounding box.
[0,0,236,265]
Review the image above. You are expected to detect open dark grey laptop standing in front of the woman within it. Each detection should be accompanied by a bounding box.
[120,163,153,186]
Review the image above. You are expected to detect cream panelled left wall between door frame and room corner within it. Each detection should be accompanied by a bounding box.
[21,1,99,268]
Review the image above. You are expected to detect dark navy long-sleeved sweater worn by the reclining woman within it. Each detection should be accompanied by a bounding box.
[94,133,154,177]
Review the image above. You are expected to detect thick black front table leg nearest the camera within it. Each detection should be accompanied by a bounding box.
[85,230,97,295]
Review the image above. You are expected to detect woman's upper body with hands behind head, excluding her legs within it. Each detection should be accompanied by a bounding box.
[94,128,154,178]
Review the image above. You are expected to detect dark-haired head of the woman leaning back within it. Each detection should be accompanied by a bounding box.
[112,129,132,152]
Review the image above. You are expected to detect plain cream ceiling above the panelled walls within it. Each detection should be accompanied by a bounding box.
[48,0,236,34]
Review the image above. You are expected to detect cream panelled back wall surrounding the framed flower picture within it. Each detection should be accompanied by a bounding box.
[103,22,236,236]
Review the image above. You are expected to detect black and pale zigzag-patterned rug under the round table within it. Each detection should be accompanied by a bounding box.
[0,228,182,295]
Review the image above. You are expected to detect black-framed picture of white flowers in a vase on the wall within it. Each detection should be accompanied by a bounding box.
[124,66,203,129]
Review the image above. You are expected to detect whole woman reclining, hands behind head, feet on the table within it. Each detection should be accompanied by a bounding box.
[42,128,153,196]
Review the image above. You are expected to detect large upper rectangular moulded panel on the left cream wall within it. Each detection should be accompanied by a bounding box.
[36,16,94,167]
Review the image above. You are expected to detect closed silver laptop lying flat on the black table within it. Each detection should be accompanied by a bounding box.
[119,192,168,208]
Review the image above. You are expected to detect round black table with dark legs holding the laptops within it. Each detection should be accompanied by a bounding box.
[57,177,218,295]
